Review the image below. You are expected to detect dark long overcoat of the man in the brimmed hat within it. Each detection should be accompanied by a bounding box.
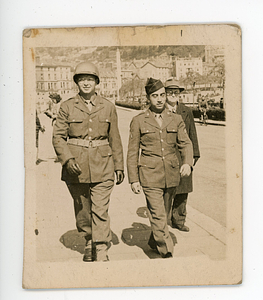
[176,103,200,194]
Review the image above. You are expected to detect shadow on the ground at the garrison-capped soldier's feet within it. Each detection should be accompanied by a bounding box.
[121,222,177,259]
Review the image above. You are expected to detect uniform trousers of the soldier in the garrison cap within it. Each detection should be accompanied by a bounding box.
[143,187,176,256]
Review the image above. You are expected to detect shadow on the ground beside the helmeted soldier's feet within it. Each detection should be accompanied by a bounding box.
[59,229,120,254]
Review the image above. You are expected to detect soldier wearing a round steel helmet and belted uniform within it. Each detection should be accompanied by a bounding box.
[53,62,124,262]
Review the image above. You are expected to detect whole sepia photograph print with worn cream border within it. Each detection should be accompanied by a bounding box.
[23,25,242,289]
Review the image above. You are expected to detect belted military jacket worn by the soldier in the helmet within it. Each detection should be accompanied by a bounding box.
[53,95,123,183]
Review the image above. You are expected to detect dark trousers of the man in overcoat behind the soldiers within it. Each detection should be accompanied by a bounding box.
[171,193,188,226]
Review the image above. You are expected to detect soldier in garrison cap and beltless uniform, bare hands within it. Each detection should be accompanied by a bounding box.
[127,78,193,258]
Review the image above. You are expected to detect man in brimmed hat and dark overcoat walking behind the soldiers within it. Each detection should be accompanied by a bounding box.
[165,78,200,232]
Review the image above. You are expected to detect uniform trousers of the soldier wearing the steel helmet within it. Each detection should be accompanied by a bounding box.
[67,180,114,244]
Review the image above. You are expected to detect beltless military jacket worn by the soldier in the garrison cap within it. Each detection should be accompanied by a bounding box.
[127,109,193,188]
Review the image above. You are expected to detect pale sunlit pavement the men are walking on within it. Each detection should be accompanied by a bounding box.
[36,108,226,261]
